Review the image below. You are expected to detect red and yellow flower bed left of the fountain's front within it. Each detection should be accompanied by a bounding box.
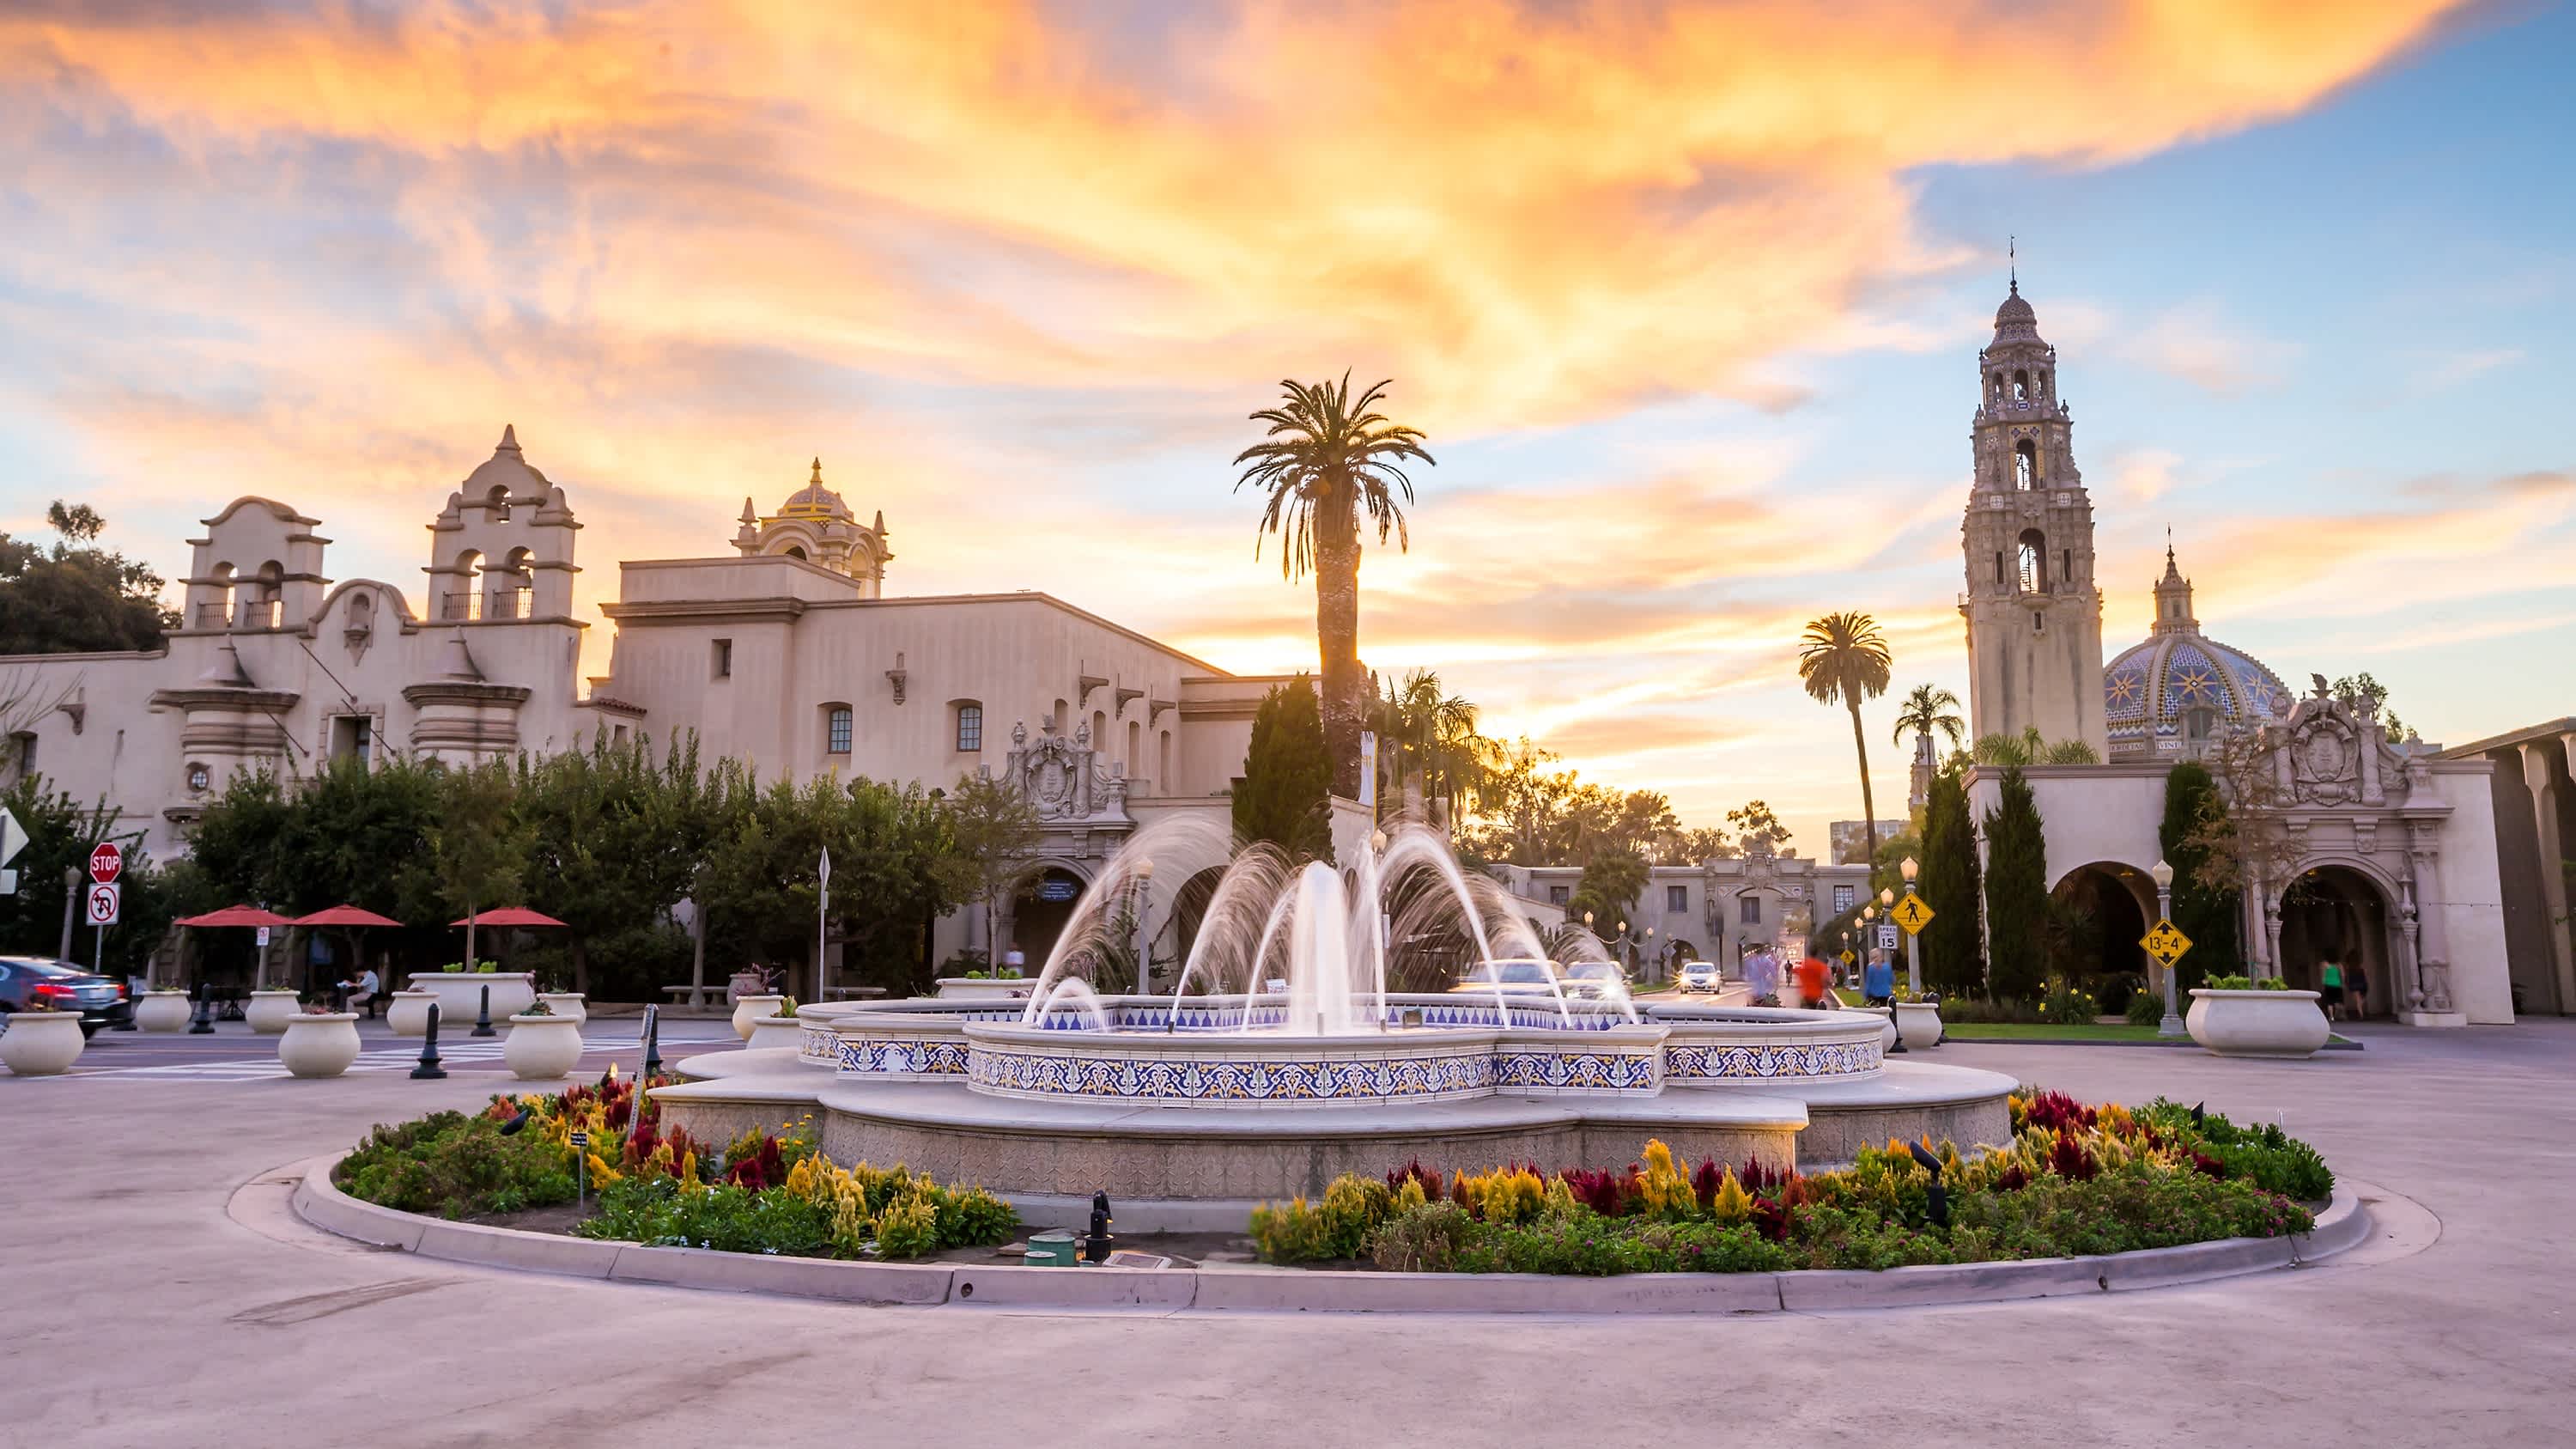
[332,1078,1020,1258]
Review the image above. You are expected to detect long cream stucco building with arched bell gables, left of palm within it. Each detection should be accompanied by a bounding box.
[0,430,1309,957]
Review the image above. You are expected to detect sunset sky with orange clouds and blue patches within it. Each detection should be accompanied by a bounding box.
[0,0,2576,854]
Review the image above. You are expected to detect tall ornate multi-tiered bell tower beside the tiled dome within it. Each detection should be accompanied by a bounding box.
[1958,276,2110,758]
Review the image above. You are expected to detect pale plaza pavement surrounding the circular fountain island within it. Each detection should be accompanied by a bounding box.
[0,1021,2576,1449]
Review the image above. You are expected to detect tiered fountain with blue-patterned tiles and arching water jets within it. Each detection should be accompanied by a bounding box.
[659,820,2012,1202]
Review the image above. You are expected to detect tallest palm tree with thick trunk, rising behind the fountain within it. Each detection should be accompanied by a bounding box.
[1234,371,1435,800]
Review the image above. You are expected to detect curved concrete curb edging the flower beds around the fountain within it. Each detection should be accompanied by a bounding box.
[283,1155,2375,1315]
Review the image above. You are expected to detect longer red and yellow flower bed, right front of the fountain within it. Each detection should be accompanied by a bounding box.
[1252,1093,2334,1276]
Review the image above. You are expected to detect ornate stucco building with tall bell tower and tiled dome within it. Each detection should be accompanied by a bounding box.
[1958,286,2514,1026]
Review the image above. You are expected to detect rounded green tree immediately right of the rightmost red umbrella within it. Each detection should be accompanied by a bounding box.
[518,735,708,995]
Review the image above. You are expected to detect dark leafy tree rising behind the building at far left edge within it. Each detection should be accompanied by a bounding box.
[0,497,178,654]
